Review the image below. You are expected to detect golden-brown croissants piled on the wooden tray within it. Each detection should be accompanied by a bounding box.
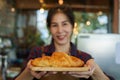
[31,52,84,67]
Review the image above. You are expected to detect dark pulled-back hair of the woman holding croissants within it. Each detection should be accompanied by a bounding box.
[47,5,75,28]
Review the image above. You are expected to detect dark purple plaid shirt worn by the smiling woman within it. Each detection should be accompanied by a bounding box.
[27,43,92,63]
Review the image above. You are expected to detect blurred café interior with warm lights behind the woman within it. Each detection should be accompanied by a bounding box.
[0,0,120,80]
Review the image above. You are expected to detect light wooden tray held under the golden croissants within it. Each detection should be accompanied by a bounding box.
[31,66,90,71]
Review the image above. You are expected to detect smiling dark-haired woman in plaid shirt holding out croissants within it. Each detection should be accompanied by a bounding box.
[15,5,112,80]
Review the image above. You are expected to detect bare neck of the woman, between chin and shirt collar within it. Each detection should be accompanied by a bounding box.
[55,43,70,54]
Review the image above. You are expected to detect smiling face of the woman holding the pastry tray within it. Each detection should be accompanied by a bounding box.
[50,13,73,45]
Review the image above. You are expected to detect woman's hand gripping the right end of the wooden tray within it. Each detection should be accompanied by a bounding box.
[64,61,95,78]
